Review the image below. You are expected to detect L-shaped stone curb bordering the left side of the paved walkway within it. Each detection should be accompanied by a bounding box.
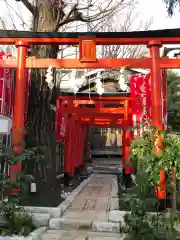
[24,174,95,218]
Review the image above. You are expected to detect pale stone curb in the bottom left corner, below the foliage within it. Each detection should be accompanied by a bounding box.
[0,227,47,240]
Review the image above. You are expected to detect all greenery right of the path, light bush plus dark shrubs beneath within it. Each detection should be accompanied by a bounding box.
[122,126,180,240]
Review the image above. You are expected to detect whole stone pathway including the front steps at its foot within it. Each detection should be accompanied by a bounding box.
[43,174,121,240]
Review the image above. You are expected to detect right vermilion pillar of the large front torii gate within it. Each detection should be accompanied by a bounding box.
[148,41,166,198]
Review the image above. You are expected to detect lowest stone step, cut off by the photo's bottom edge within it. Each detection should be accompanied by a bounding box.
[42,229,122,240]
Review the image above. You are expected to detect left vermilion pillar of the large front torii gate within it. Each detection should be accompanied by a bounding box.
[10,41,28,182]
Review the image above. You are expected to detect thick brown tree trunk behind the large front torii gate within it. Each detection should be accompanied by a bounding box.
[27,0,62,187]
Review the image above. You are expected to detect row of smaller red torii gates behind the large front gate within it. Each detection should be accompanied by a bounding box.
[56,93,133,178]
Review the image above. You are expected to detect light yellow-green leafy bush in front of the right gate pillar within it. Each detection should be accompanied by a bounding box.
[130,127,180,190]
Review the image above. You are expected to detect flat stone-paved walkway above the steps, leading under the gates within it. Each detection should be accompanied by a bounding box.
[63,174,114,220]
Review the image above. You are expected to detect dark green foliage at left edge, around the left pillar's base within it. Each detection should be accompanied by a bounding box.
[0,142,44,236]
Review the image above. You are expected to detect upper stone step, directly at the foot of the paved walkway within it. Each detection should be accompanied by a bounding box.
[49,218,121,233]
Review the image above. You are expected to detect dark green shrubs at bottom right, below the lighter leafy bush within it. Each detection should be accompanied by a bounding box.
[122,170,177,240]
